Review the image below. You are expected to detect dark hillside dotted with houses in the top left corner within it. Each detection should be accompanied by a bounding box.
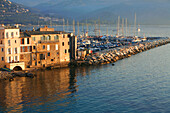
[0,0,46,24]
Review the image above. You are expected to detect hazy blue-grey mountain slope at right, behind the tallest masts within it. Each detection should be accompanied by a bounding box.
[86,1,170,25]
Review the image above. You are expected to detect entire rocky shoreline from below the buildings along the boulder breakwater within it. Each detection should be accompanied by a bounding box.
[0,38,170,81]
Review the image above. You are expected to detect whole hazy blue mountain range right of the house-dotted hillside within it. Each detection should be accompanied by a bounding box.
[3,0,170,24]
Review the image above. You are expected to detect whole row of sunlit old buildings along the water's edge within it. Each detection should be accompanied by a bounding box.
[0,26,77,70]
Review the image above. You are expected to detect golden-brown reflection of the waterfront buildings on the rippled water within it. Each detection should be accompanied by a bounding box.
[0,68,78,112]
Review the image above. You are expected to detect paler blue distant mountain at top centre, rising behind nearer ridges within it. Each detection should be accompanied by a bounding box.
[33,0,116,19]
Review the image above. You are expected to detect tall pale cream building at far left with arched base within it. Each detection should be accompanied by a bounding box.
[0,27,25,69]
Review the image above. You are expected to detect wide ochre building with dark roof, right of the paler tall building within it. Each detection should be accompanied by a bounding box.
[20,26,77,67]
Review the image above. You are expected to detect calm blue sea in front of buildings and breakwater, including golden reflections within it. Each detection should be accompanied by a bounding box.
[0,25,170,113]
